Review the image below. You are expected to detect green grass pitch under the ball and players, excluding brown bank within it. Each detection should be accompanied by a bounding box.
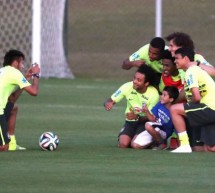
[0,78,215,193]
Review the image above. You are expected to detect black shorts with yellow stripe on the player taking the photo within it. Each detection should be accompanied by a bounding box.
[0,115,10,146]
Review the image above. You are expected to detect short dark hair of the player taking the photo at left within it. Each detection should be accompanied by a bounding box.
[3,50,25,66]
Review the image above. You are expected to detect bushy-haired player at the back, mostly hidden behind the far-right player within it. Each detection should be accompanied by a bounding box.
[165,32,215,76]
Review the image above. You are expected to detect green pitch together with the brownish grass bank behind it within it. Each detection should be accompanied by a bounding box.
[0,0,215,193]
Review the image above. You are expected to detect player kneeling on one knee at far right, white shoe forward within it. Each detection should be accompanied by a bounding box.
[170,47,215,153]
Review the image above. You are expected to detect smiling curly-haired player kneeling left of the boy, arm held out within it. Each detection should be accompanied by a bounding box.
[104,65,159,148]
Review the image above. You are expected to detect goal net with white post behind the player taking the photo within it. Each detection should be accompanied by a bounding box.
[0,0,74,78]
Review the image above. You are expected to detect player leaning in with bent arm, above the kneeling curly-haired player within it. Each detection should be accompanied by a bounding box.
[122,37,165,83]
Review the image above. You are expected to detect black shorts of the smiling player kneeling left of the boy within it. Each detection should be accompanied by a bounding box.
[119,121,145,139]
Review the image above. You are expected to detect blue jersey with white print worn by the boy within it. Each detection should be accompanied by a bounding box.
[152,102,174,137]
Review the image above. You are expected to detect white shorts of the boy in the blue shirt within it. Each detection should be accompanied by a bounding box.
[134,122,166,146]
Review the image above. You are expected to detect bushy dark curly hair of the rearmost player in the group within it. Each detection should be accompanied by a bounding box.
[165,32,195,50]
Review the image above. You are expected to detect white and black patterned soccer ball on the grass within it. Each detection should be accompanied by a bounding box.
[39,132,59,151]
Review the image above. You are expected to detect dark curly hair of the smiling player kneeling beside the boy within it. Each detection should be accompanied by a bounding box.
[137,64,156,85]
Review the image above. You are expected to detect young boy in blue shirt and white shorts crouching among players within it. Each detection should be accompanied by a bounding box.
[131,86,179,150]
